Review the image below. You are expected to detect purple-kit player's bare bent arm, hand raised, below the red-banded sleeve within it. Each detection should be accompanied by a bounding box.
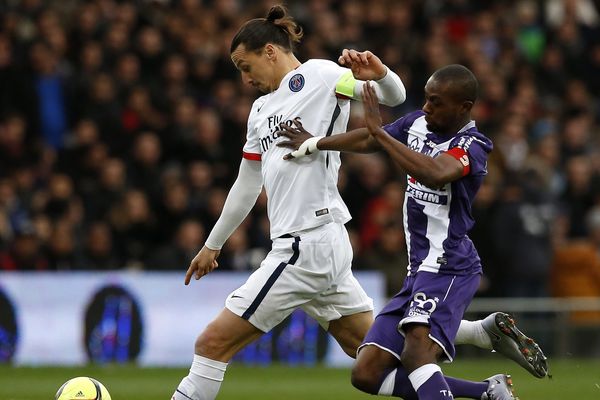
[363,82,464,188]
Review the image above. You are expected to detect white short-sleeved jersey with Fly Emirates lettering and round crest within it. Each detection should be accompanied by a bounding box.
[243,60,351,239]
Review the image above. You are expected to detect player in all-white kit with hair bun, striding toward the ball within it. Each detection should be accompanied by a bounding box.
[172,6,406,400]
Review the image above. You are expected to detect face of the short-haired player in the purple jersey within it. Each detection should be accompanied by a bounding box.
[422,78,473,135]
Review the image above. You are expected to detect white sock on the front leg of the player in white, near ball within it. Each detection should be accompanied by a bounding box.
[171,354,227,400]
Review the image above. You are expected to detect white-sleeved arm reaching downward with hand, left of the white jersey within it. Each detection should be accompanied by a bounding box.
[185,159,262,285]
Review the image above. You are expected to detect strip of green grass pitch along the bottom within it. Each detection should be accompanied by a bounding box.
[0,359,600,400]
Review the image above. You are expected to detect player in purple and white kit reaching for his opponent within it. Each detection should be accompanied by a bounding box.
[278,64,547,400]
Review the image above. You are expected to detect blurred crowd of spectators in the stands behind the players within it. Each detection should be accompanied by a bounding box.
[0,0,600,296]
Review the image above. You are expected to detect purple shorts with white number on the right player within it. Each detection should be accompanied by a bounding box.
[359,271,481,362]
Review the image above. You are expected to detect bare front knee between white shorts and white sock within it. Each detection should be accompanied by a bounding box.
[195,308,263,362]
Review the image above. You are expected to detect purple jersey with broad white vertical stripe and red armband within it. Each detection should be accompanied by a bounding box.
[383,111,492,275]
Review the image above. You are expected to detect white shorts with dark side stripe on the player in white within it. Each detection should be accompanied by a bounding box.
[225,223,373,332]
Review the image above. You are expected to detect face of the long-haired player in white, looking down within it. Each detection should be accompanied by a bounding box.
[231,44,277,93]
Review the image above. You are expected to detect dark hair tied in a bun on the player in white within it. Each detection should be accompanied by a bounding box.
[229,4,303,53]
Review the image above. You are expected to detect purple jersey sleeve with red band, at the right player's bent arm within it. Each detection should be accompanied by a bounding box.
[446,134,491,176]
